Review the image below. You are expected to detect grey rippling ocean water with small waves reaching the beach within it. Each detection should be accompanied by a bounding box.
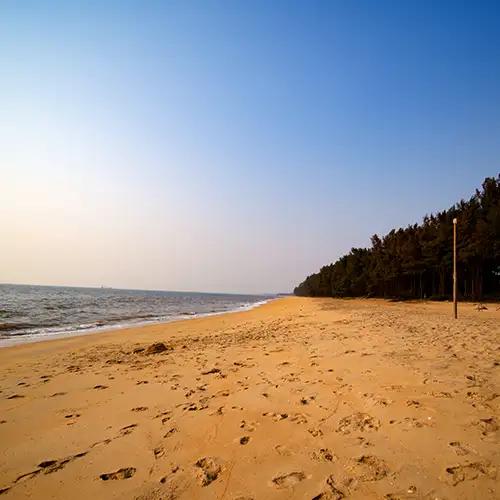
[0,284,273,347]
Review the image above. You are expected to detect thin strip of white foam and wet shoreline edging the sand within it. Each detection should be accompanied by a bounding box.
[0,297,279,349]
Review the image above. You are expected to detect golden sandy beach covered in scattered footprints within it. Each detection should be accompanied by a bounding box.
[0,297,500,500]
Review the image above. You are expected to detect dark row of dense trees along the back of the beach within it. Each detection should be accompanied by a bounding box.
[294,175,500,300]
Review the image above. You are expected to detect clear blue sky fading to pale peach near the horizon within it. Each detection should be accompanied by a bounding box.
[0,0,500,293]
